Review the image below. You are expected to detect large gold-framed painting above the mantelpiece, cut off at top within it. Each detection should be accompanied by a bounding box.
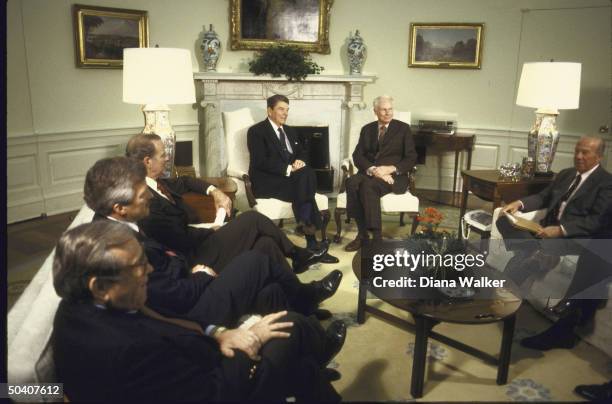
[230,0,333,53]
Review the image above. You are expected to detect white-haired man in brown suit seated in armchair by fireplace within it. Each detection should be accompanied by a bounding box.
[344,96,417,251]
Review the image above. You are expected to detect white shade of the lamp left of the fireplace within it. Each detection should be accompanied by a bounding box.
[123,48,195,104]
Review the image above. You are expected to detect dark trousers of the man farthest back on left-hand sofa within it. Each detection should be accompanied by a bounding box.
[193,211,295,273]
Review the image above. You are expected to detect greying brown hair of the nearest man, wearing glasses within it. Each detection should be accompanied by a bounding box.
[53,220,136,302]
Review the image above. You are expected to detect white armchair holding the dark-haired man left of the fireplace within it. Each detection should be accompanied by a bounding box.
[222,108,330,240]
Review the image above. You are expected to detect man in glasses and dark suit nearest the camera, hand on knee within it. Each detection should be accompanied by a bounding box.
[51,221,341,402]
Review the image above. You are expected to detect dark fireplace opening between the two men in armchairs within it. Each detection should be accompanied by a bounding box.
[293,126,334,193]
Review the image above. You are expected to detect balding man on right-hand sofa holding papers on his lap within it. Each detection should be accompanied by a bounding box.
[496,136,612,350]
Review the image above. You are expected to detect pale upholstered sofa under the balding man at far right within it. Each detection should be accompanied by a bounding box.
[487,208,612,356]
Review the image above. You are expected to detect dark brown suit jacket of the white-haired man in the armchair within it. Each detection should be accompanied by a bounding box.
[353,119,417,193]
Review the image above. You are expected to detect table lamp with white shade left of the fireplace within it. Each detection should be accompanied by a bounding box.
[123,48,195,177]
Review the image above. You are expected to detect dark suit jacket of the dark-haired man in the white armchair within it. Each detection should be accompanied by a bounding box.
[247,118,306,198]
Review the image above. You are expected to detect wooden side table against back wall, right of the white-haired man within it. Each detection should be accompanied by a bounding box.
[413,132,476,200]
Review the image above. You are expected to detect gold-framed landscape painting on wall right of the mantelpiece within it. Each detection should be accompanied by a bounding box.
[408,23,484,69]
